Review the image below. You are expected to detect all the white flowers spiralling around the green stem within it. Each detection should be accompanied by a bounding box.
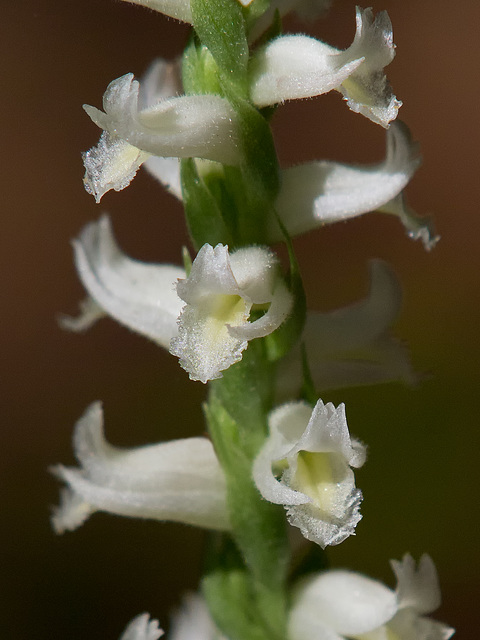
[52,0,453,640]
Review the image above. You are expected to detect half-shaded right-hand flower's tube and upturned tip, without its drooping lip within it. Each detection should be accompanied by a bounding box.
[269,122,420,242]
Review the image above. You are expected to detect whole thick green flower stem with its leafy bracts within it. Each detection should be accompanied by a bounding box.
[181,0,296,640]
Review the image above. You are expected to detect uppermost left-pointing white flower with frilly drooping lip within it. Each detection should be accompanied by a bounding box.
[83,61,240,202]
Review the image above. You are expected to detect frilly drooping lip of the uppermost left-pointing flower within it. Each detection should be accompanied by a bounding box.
[83,131,150,203]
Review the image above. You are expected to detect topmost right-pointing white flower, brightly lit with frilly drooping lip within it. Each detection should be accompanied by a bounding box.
[250,7,401,127]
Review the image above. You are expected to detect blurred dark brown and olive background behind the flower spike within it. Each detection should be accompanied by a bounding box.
[0,0,480,640]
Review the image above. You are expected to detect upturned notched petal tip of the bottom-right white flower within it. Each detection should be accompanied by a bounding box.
[390,553,441,614]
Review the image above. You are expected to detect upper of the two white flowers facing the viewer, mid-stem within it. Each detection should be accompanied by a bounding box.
[170,244,292,382]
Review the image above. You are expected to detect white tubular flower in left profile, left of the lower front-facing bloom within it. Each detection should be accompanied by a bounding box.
[52,402,229,533]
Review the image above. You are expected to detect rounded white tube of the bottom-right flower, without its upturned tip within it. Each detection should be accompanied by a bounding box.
[290,571,397,640]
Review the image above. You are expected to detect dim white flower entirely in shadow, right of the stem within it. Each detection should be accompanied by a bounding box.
[277,260,417,400]
